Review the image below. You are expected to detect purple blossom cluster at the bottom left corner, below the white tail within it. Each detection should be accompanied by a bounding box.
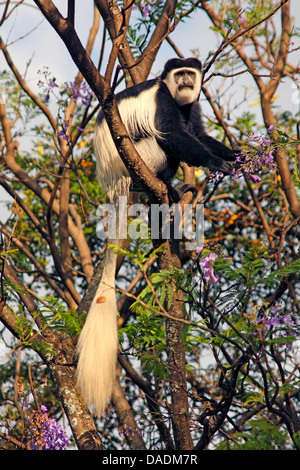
[28,405,70,450]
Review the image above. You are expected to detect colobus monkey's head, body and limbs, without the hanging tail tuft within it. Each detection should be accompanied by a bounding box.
[94,58,235,201]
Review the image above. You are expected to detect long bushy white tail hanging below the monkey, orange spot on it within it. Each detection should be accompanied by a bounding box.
[77,249,118,416]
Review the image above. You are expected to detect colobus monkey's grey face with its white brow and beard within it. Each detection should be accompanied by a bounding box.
[163,67,201,106]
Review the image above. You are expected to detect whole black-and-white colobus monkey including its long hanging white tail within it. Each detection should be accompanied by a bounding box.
[78,58,235,415]
